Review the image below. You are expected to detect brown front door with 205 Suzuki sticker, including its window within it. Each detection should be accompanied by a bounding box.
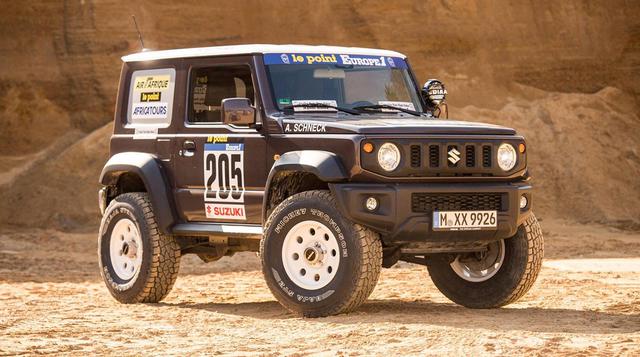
[172,56,267,224]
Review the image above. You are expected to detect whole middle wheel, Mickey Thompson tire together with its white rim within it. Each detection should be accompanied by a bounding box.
[260,190,382,317]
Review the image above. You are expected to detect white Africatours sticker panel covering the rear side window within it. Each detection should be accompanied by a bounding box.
[127,68,176,128]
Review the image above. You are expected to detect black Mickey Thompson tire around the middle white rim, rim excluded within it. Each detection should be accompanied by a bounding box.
[260,190,382,317]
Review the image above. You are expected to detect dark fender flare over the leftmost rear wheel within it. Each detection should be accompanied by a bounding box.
[100,152,176,234]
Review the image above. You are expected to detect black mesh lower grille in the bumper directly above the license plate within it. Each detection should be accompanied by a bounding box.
[411,193,504,213]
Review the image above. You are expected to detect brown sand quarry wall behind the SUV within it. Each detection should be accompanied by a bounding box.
[0,0,640,229]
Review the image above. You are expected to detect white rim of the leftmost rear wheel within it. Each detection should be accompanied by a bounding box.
[109,218,142,281]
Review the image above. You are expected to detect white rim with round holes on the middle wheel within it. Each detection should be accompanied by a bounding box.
[282,221,340,290]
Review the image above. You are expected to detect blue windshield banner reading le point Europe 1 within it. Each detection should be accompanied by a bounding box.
[264,53,407,68]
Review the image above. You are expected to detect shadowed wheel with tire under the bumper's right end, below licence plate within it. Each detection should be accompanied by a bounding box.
[427,214,544,309]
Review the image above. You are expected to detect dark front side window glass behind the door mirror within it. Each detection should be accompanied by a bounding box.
[188,66,254,123]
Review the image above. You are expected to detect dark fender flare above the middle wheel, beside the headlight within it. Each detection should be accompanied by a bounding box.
[262,150,349,222]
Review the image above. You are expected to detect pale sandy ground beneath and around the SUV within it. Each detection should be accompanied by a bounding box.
[0,221,640,356]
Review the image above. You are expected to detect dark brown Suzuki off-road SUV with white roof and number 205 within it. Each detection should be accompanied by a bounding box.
[99,45,543,316]
